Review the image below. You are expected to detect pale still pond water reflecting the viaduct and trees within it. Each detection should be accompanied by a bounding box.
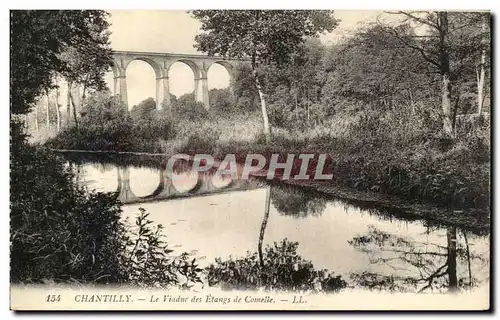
[65,154,490,291]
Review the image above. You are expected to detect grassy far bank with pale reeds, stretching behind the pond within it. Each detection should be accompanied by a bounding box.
[46,107,490,216]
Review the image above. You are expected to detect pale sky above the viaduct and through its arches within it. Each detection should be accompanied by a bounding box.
[106,10,381,108]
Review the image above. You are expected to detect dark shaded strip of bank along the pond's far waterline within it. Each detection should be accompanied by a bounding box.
[53,146,490,234]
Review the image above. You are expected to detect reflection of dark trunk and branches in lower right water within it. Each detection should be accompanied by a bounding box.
[349,226,487,292]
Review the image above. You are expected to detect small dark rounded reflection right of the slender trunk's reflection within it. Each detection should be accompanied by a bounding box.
[271,186,326,218]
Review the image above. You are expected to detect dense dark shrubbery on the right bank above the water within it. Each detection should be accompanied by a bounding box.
[331,107,490,210]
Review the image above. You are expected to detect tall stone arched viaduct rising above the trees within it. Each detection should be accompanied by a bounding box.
[112,51,245,110]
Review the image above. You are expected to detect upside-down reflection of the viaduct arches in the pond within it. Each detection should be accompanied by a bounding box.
[116,167,259,204]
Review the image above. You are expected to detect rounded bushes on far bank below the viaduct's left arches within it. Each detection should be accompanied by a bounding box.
[47,92,174,152]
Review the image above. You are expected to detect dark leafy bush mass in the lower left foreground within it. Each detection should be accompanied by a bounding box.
[10,144,126,283]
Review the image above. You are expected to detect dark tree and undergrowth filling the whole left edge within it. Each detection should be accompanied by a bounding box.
[10,10,128,283]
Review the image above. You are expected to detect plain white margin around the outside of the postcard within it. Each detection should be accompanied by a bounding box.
[0,0,500,319]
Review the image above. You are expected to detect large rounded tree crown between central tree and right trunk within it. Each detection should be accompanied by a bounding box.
[322,25,440,113]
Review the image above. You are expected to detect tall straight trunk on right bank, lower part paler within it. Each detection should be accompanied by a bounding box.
[438,11,453,137]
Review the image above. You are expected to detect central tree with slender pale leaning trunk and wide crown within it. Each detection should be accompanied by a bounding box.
[192,10,337,140]
